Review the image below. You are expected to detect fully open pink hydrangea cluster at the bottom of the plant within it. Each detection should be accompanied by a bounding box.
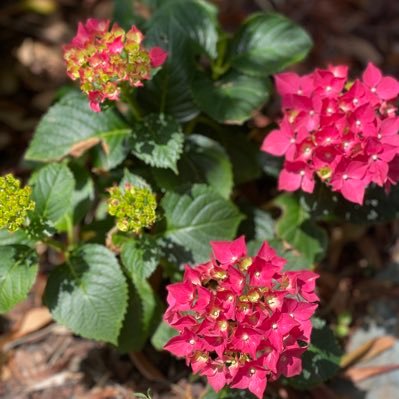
[164,237,318,399]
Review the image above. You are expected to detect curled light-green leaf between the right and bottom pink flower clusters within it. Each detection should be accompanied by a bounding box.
[274,194,327,263]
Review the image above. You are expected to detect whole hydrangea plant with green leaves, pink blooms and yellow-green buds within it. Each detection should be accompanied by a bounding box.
[0,0,399,398]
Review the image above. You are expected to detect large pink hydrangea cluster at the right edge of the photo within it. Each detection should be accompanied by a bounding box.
[262,63,399,204]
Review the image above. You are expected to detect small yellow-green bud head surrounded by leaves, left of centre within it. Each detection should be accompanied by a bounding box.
[108,184,157,233]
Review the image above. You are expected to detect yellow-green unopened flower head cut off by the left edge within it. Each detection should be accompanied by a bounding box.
[0,174,35,231]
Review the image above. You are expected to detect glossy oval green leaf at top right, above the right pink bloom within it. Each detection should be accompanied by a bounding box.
[229,13,312,76]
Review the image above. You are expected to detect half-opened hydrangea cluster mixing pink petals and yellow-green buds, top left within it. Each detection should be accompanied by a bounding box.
[64,19,167,112]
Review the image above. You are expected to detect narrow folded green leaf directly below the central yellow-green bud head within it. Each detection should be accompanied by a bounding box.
[119,237,160,351]
